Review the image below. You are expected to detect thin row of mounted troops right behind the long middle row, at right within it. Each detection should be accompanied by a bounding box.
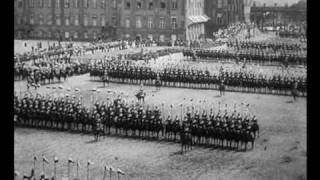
[183,49,307,65]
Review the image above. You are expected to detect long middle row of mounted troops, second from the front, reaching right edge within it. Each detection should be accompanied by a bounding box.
[89,58,307,96]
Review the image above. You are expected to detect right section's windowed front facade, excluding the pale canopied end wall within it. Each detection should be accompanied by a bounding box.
[118,0,185,41]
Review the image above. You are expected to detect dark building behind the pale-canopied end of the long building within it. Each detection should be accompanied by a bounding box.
[205,0,245,37]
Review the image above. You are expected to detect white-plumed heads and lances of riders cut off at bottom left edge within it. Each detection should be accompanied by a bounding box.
[14,154,125,180]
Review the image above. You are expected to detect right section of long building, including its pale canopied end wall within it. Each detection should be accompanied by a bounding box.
[118,0,208,41]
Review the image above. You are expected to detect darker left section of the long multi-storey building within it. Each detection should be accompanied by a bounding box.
[14,0,117,40]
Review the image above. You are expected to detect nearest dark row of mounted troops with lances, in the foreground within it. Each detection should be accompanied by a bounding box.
[14,94,259,149]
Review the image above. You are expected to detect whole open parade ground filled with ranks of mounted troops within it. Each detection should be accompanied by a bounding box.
[14,26,307,180]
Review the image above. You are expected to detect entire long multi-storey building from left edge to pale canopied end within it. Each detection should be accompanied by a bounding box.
[14,0,208,41]
